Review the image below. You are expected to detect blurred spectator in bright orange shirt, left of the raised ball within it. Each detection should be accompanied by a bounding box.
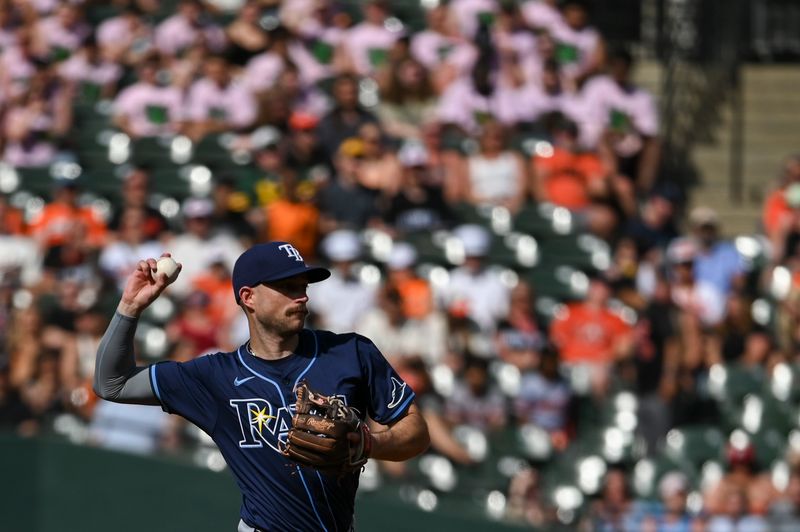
[30,179,107,249]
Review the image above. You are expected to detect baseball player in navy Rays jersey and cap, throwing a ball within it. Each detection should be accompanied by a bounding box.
[94,242,429,532]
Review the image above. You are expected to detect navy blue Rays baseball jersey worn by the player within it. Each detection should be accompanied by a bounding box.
[150,329,414,532]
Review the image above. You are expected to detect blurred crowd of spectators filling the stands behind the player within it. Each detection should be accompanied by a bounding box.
[0,0,800,531]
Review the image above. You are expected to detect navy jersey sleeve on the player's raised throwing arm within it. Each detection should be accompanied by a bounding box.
[150,356,218,434]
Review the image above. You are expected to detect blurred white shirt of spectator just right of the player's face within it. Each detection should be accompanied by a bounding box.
[308,270,375,333]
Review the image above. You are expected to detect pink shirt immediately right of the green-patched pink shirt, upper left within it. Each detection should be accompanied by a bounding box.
[186,78,257,129]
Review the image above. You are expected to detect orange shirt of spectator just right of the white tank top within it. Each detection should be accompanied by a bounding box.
[533,147,608,210]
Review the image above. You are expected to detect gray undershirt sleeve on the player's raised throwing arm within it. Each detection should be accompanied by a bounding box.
[94,312,160,405]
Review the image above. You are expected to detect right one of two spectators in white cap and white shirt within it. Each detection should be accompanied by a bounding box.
[443,224,509,333]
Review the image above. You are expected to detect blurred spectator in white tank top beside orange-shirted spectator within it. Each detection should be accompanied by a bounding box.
[465,120,528,214]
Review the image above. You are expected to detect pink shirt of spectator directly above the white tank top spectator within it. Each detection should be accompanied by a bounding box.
[436,79,524,133]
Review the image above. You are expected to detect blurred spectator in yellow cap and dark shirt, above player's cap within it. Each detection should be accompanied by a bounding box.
[318,138,379,232]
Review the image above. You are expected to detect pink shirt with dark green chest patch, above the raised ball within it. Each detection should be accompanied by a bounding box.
[114,82,183,137]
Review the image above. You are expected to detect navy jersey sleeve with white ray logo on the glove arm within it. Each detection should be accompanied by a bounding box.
[356,336,415,424]
